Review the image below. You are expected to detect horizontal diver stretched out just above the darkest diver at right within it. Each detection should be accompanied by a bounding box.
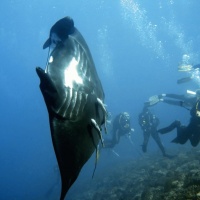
[158,89,200,110]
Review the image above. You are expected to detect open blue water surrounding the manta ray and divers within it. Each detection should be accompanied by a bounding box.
[0,0,200,200]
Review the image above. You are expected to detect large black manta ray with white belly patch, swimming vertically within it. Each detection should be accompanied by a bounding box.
[36,17,106,199]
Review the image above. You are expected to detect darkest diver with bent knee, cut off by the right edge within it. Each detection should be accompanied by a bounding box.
[158,99,200,147]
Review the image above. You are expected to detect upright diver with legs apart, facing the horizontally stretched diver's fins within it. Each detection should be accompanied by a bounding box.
[138,104,172,158]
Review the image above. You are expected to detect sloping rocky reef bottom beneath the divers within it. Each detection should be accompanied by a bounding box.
[72,148,200,200]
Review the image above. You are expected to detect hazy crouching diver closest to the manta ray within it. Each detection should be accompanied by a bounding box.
[104,112,133,148]
